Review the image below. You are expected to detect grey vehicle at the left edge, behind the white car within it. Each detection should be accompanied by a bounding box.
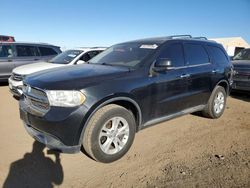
[0,42,61,82]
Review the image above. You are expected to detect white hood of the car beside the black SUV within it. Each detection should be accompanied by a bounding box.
[13,62,65,75]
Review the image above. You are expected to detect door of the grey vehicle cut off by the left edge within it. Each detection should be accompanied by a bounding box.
[0,44,14,79]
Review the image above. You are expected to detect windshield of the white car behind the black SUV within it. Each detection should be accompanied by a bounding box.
[49,50,83,64]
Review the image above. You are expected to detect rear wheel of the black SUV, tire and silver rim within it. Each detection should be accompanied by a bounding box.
[202,86,227,119]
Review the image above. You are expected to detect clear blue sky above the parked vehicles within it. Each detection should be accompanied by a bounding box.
[0,0,250,48]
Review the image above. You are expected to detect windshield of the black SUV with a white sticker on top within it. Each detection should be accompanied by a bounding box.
[89,42,158,68]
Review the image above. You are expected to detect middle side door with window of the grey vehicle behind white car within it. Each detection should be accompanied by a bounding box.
[14,44,40,67]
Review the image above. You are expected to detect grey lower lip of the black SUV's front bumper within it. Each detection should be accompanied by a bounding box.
[24,123,81,153]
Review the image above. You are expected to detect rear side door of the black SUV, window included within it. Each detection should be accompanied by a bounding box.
[184,42,214,108]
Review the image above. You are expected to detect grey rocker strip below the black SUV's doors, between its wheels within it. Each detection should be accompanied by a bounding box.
[142,105,206,127]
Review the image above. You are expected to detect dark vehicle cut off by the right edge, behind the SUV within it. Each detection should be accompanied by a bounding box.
[232,48,250,91]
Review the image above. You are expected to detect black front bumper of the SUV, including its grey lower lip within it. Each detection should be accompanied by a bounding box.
[19,97,88,153]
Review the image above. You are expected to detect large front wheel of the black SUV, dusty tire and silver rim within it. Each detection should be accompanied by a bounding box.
[82,104,136,163]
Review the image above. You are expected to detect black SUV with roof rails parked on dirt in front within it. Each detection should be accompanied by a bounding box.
[20,36,232,163]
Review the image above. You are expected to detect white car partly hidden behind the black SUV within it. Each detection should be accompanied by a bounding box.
[8,47,106,97]
